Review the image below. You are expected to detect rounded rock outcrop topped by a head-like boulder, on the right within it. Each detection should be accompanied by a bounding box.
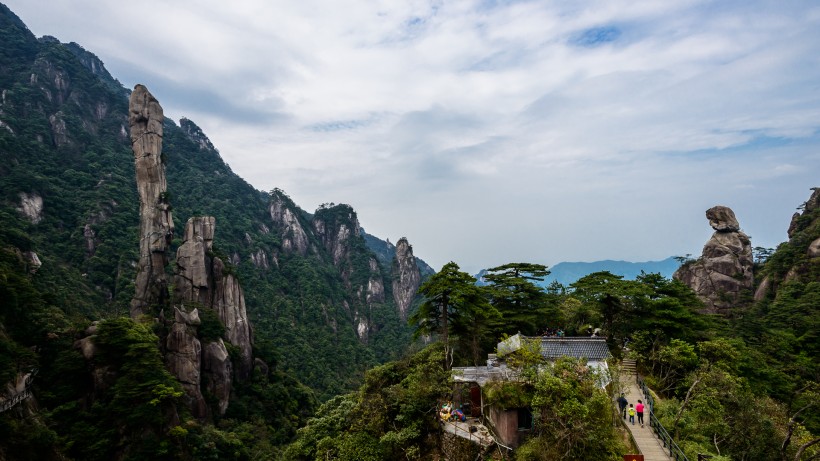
[673,206,754,313]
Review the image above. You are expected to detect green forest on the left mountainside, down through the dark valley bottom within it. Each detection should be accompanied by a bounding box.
[0,5,412,459]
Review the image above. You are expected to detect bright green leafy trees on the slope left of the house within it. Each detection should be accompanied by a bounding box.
[284,343,450,460]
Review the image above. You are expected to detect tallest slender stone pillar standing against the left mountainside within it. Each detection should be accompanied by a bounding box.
[128,85,174,318]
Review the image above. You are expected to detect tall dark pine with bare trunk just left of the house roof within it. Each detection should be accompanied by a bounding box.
[408,261,494,369]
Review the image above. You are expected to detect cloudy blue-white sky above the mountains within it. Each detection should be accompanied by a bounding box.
[6,0,820,273]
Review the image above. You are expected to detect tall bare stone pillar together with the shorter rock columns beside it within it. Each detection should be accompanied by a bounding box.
[129,85,253,419]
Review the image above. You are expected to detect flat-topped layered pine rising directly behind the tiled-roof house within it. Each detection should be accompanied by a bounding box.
[484,263,550,336]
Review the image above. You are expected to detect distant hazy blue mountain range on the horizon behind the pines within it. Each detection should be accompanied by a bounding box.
[475,256,680,286]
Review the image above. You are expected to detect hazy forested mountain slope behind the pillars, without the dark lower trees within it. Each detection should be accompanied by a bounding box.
[0,4,426,452]
